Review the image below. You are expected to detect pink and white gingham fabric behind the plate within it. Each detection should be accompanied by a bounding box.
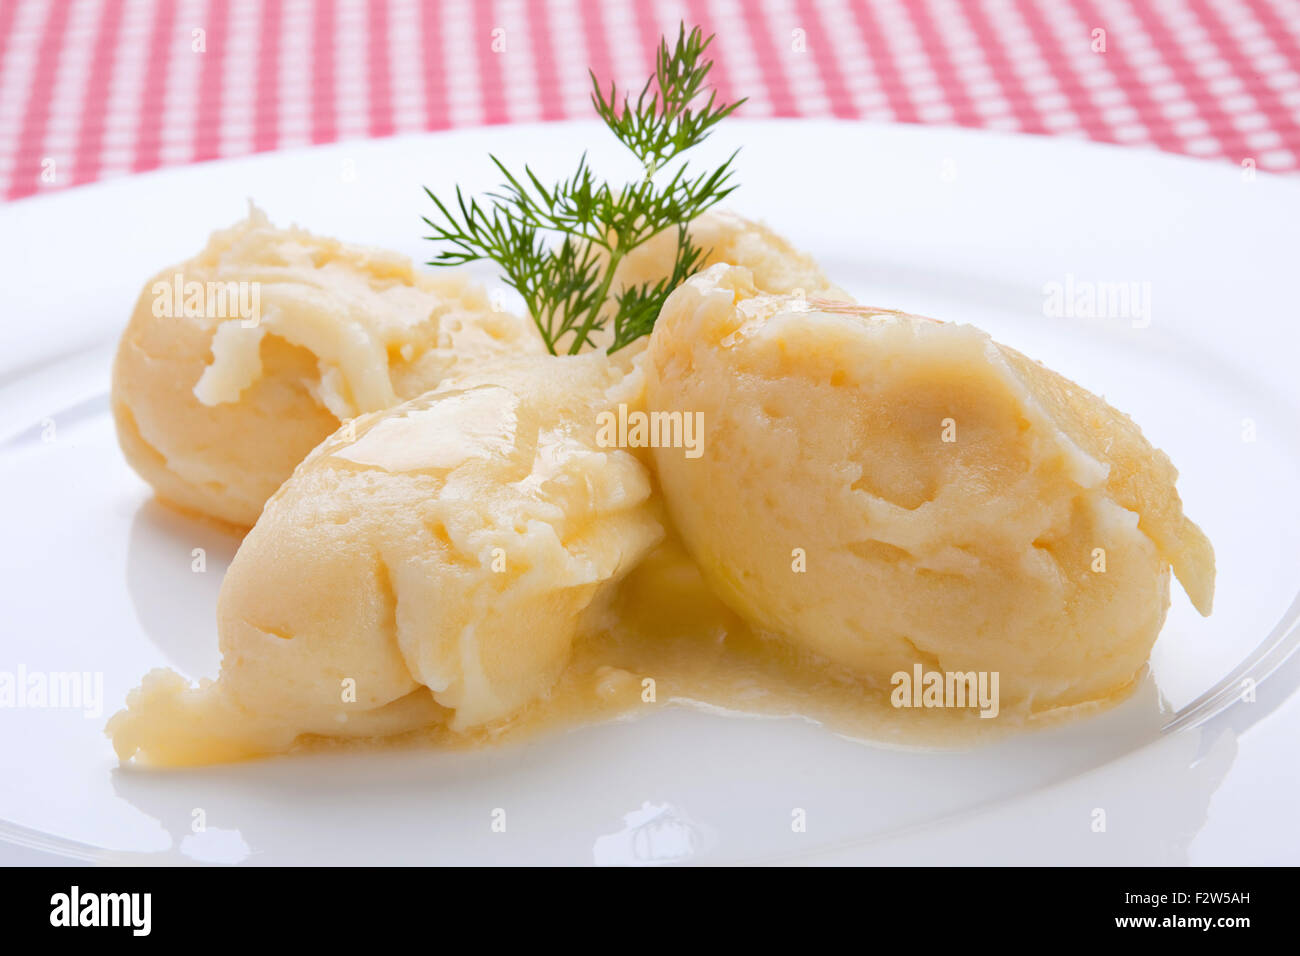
[0,0,1300,199]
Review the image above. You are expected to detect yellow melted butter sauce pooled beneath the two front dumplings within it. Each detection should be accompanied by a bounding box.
[299,538,1136,750]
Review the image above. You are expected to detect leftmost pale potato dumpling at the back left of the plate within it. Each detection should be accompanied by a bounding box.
[112,208,542,527]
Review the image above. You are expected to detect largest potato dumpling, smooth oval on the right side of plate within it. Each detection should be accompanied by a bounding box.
[646,265,1214,713]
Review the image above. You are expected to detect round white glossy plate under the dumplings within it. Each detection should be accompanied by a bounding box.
[0,121,1300,864]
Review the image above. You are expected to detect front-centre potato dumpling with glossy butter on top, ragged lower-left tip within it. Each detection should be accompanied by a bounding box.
[108,347,663,765]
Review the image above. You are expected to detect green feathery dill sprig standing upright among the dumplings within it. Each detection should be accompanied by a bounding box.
[424,25,744,355]
